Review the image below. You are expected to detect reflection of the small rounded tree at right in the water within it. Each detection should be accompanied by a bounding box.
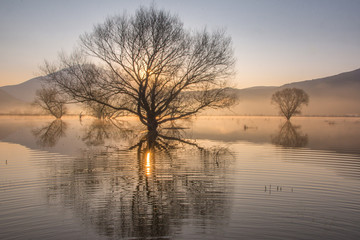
[271,121,308,147]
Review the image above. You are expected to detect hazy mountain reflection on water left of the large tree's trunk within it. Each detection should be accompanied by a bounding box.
[0,116,143,156]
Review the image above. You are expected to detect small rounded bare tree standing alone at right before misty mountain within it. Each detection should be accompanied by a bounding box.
[271,88,309,120]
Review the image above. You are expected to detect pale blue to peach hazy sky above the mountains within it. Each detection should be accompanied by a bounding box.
[0,0,360,88]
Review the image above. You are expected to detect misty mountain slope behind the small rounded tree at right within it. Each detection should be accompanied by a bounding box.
[228,69,360,116]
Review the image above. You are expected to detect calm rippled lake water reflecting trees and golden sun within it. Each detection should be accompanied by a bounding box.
[0,116,360,239]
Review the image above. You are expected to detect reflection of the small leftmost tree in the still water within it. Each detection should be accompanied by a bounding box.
[32,119,67,147]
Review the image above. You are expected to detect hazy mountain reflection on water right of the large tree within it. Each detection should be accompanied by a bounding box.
[189,117,360,153]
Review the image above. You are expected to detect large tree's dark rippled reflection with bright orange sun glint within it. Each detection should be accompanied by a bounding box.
[48,124,230,238]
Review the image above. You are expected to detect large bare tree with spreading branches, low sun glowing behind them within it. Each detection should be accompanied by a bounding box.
[45,7,234,130]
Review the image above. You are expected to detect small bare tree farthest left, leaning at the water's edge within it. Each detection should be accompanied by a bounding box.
[33,87,67,119]
